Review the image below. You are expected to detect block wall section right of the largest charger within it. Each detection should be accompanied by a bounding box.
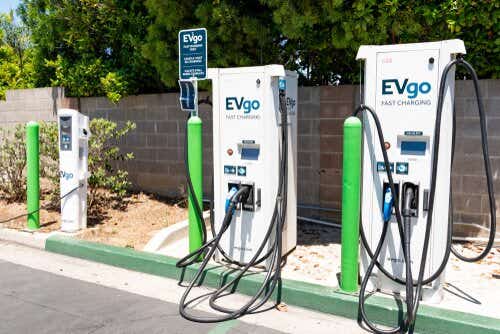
[452,80,500,234]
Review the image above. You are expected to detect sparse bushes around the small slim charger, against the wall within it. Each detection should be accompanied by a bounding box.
[0,118,135,216]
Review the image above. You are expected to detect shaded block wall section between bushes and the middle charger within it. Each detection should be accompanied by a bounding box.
[80,93,212,196]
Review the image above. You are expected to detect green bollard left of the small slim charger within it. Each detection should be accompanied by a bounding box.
[26,122,40,230]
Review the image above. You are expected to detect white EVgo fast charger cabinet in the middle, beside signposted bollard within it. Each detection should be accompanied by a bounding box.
[208,65,297,262]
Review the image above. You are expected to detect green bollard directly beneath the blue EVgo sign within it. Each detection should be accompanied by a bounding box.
[187,116,205,252]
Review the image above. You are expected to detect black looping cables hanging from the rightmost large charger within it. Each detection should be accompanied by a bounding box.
[355,56,496,334]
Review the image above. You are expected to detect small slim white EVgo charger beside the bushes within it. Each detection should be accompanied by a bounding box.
[57,109,90,232]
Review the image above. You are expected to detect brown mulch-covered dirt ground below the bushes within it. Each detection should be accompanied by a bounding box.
[0,193,187,250]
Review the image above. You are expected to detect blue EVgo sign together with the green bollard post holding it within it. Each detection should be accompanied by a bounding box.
[179,28,207,253]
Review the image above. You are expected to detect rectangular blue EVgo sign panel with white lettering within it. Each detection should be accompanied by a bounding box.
[179,28,207,80]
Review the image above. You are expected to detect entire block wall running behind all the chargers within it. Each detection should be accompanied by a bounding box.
[0,80,500,236]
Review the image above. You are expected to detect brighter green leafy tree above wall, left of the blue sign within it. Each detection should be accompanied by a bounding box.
[19,0,164,101]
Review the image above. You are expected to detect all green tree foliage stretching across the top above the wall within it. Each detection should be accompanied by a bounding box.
[0,0,500,94]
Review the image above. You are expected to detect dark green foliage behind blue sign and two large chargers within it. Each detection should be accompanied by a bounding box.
[144,0,500,86]
